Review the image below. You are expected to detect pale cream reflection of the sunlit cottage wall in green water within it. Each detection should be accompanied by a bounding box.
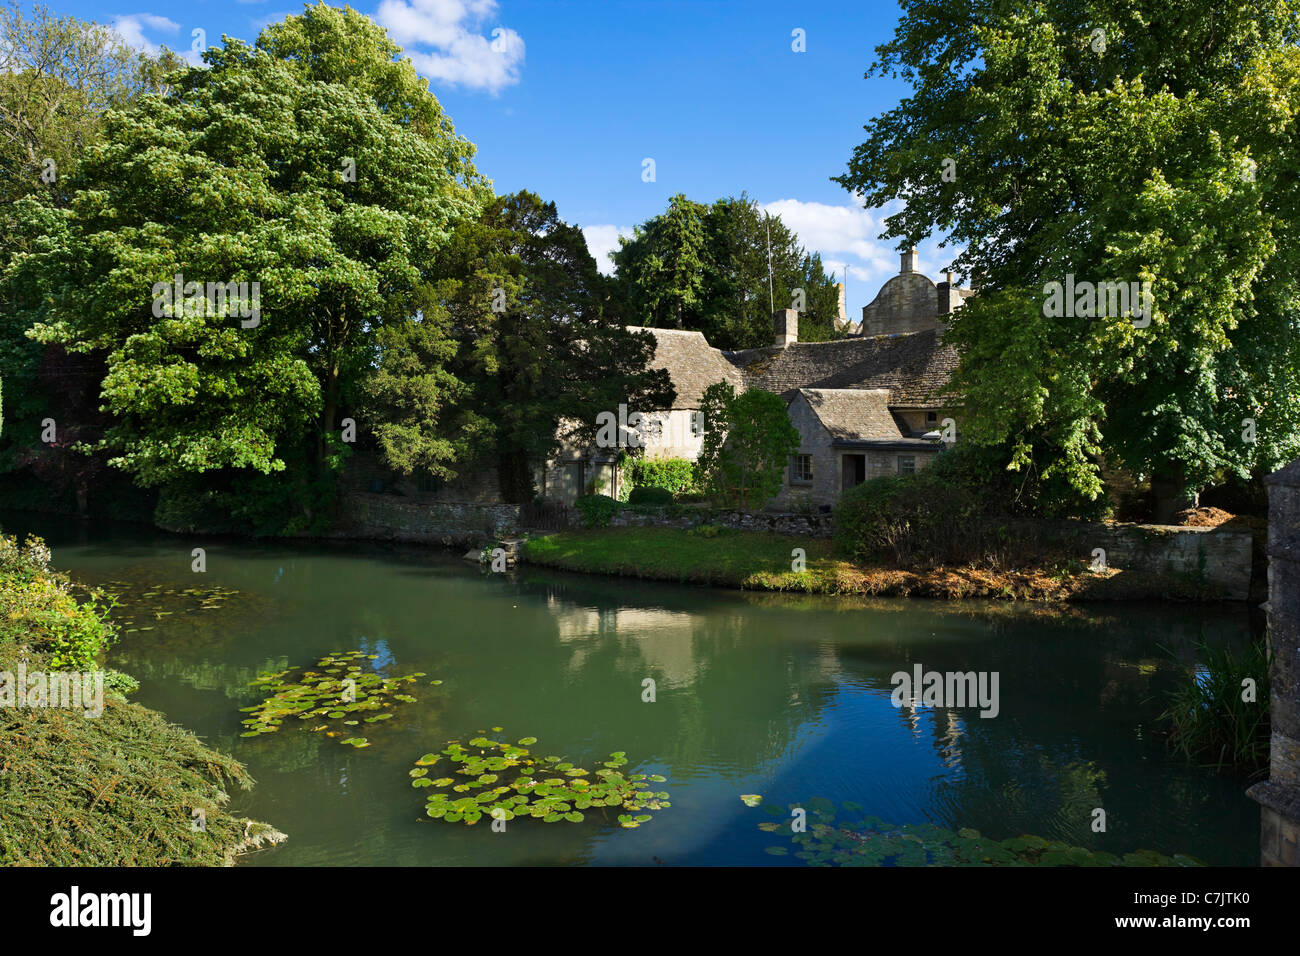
[546,596,705,688]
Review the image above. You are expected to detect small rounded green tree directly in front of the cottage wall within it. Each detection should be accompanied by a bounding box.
[694,382,800,509]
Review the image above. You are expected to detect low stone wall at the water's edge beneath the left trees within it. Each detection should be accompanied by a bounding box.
[334,492,519,548]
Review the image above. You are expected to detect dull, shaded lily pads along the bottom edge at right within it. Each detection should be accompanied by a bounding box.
[758,800,1204,866]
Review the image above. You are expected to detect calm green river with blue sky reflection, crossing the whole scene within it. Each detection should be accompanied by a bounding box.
[4,514,1258,865]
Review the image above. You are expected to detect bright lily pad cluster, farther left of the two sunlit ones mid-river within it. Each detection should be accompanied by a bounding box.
[239,650,431,747]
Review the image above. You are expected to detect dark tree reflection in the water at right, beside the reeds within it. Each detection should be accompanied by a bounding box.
[898,607,1249,853]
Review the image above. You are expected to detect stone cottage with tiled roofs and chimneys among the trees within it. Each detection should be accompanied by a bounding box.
[538,250,972,507]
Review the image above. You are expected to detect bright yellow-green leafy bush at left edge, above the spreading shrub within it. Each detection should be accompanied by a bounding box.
[0,535,117,671]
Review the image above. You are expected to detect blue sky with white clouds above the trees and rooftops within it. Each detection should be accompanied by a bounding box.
[61,0,953,317]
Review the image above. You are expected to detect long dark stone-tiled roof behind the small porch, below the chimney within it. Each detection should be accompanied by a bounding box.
[728,329,959,408]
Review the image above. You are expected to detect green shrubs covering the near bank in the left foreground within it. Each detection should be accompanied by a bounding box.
[0,536,283,866]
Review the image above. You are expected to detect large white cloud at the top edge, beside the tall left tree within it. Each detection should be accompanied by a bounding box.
[374,0,524,94]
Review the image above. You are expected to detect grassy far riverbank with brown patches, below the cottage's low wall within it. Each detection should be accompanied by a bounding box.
[524,527,1227,601]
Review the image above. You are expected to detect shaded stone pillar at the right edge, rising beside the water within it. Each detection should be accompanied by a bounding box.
[1247,460,1300,866]
